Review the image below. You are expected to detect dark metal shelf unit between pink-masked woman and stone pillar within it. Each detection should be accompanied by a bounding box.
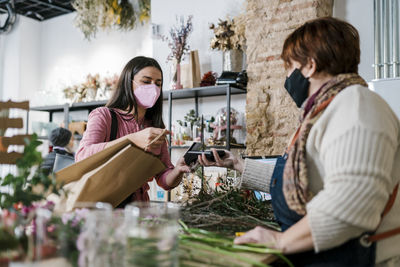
[163,84,247,154]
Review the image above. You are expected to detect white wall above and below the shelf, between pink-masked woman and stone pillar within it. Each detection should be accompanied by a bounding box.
[151,0,246,135]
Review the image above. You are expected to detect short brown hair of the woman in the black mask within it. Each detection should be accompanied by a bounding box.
[281,17,360,75]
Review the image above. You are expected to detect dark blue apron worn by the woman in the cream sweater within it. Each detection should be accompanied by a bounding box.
[270,154,376,267]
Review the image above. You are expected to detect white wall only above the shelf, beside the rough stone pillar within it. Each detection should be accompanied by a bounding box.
[151,0,246,89]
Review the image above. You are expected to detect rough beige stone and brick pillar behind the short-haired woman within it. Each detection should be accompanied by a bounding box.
[246,0,333,155]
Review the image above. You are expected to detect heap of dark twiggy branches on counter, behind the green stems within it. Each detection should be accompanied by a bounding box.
[181,168,280,235]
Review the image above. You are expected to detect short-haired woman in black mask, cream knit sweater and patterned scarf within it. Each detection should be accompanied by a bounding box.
[199,18,400,266]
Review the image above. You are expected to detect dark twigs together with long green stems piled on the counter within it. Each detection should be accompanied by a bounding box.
[179,185,293,267]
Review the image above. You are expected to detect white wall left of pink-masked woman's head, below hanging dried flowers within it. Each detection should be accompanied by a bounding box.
[0,13,152,106]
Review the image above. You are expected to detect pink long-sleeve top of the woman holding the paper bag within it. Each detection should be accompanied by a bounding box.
[75,107,174,201]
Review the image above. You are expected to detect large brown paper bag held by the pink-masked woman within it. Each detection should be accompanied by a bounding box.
[56,140,165,212]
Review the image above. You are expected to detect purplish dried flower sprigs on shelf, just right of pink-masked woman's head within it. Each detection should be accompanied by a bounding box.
[161,16,193,64]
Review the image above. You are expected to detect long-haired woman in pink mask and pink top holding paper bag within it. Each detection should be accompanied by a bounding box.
[75,56,190,206]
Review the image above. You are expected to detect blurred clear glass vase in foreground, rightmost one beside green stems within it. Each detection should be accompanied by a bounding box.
[125,201,179,267]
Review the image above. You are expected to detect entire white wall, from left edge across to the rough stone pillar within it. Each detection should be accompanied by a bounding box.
[0,0,250,148]
